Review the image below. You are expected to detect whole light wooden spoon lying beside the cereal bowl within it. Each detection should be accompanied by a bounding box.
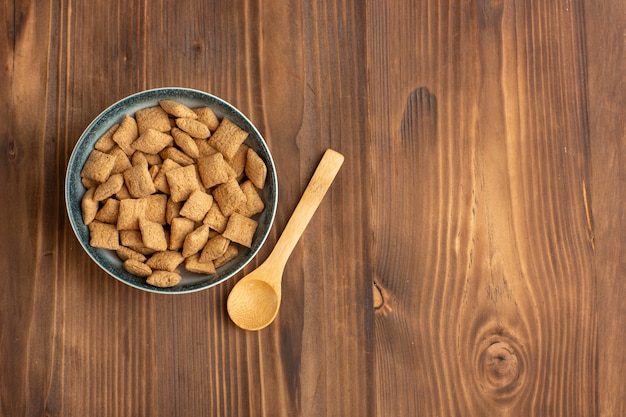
[227,149,344,330]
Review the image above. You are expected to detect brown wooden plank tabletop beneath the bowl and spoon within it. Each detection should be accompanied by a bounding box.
[0,0,626,417]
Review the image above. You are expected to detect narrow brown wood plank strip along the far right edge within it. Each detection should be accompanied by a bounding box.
[584,1,626,416]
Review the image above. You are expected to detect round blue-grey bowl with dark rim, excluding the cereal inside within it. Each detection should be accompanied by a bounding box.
[65,88,278,294]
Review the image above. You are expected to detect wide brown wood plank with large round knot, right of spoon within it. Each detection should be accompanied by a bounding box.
[368,1,597,416]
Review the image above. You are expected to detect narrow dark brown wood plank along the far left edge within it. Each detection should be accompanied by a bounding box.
[0,1,60,415]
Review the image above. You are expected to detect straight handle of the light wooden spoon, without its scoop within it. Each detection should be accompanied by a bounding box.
[270,149,344,270]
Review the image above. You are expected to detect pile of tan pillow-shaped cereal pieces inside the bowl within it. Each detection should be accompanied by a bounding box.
[81,100,267,287]
